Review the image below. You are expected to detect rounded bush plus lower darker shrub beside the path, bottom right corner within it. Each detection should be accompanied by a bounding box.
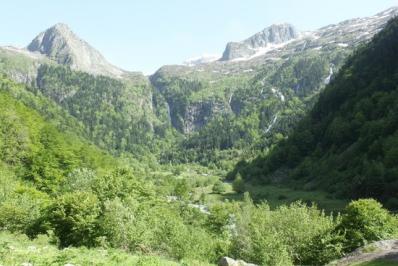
[302,199,398,265]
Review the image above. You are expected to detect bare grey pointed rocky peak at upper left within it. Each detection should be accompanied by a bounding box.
[27,23,123,77]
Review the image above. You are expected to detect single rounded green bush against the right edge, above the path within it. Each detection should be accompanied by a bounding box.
[338,199,398,251]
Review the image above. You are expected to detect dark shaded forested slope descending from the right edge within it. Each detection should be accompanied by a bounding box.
[235,18,398,208]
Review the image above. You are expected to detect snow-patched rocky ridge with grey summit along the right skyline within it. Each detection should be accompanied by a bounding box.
[183,7,398,65]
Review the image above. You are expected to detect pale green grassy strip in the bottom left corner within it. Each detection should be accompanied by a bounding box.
[0,232,187,266]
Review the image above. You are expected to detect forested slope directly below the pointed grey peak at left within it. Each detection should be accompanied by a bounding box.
[31,65,174,155]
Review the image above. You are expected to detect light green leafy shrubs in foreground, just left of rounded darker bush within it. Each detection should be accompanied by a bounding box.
[232,195,335,265]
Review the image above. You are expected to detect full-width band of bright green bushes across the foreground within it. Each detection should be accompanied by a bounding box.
[0,165,398,266]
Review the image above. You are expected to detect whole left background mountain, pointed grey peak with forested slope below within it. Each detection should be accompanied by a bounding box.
[0,24,173,154]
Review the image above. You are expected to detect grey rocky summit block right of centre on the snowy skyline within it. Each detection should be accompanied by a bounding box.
[221,23,299,61]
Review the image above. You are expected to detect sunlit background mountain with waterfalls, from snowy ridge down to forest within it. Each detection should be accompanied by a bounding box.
[150,8,398,163]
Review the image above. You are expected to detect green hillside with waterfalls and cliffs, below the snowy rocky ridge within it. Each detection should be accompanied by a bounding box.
[157,49,348,165]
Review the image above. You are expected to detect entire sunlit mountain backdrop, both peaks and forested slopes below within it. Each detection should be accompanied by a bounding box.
[0,8,397,166]
